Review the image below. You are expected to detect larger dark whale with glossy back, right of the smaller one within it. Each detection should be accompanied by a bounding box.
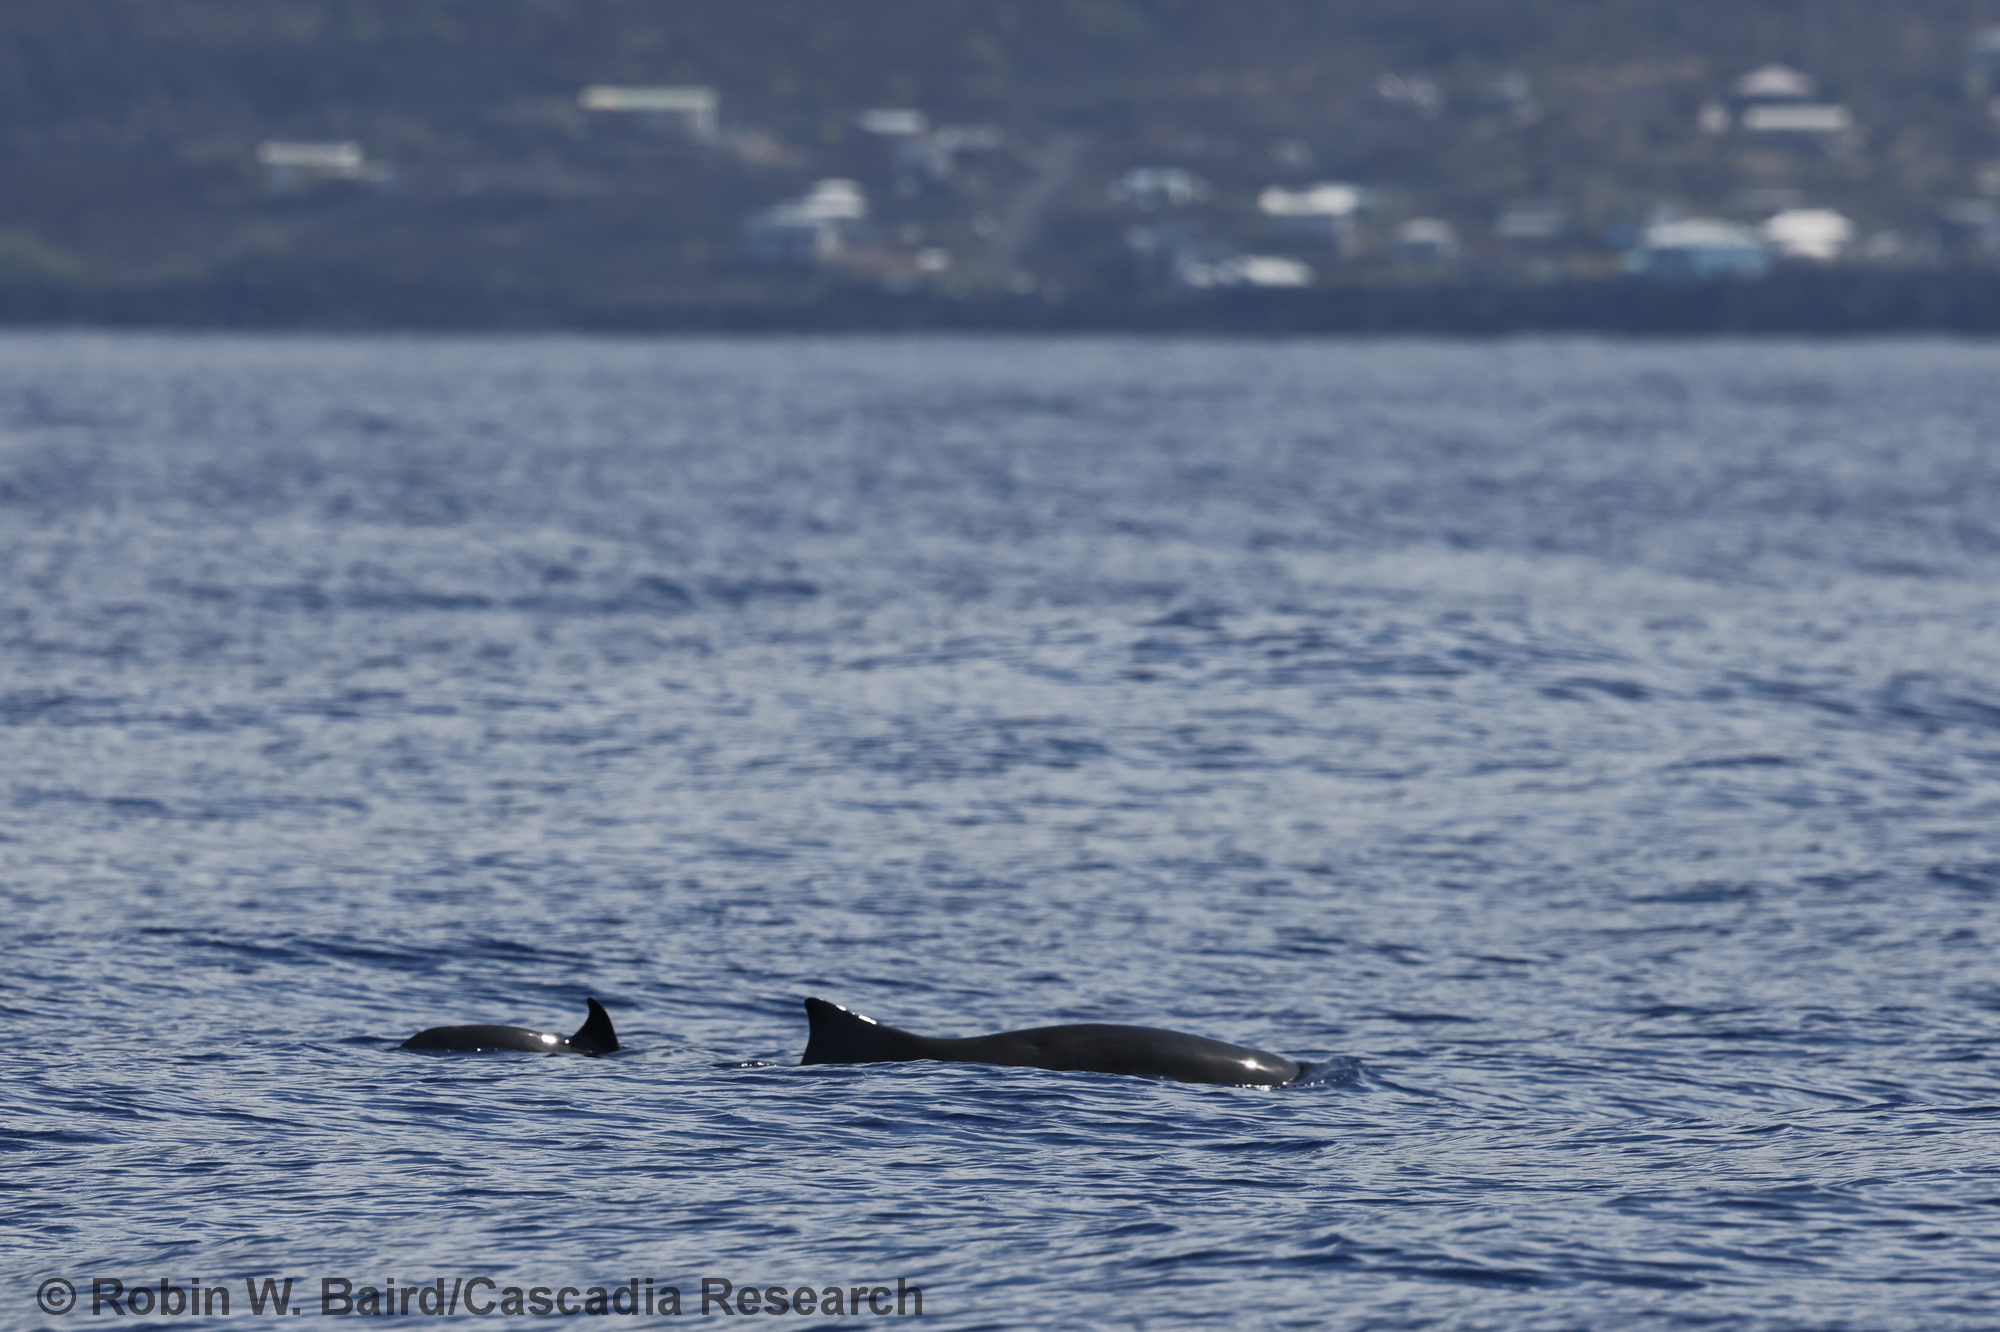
[798,998,1306,1086]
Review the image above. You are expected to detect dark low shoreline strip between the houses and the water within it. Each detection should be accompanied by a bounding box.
[0,268,2000,336]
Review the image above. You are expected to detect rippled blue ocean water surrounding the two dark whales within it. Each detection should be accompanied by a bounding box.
[0,332,2000,1330]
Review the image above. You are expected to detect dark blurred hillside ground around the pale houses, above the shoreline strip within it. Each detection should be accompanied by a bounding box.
[0,0,2000,316]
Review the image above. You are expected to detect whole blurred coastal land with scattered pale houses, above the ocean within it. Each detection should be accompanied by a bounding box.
[11,0,2000,330]
